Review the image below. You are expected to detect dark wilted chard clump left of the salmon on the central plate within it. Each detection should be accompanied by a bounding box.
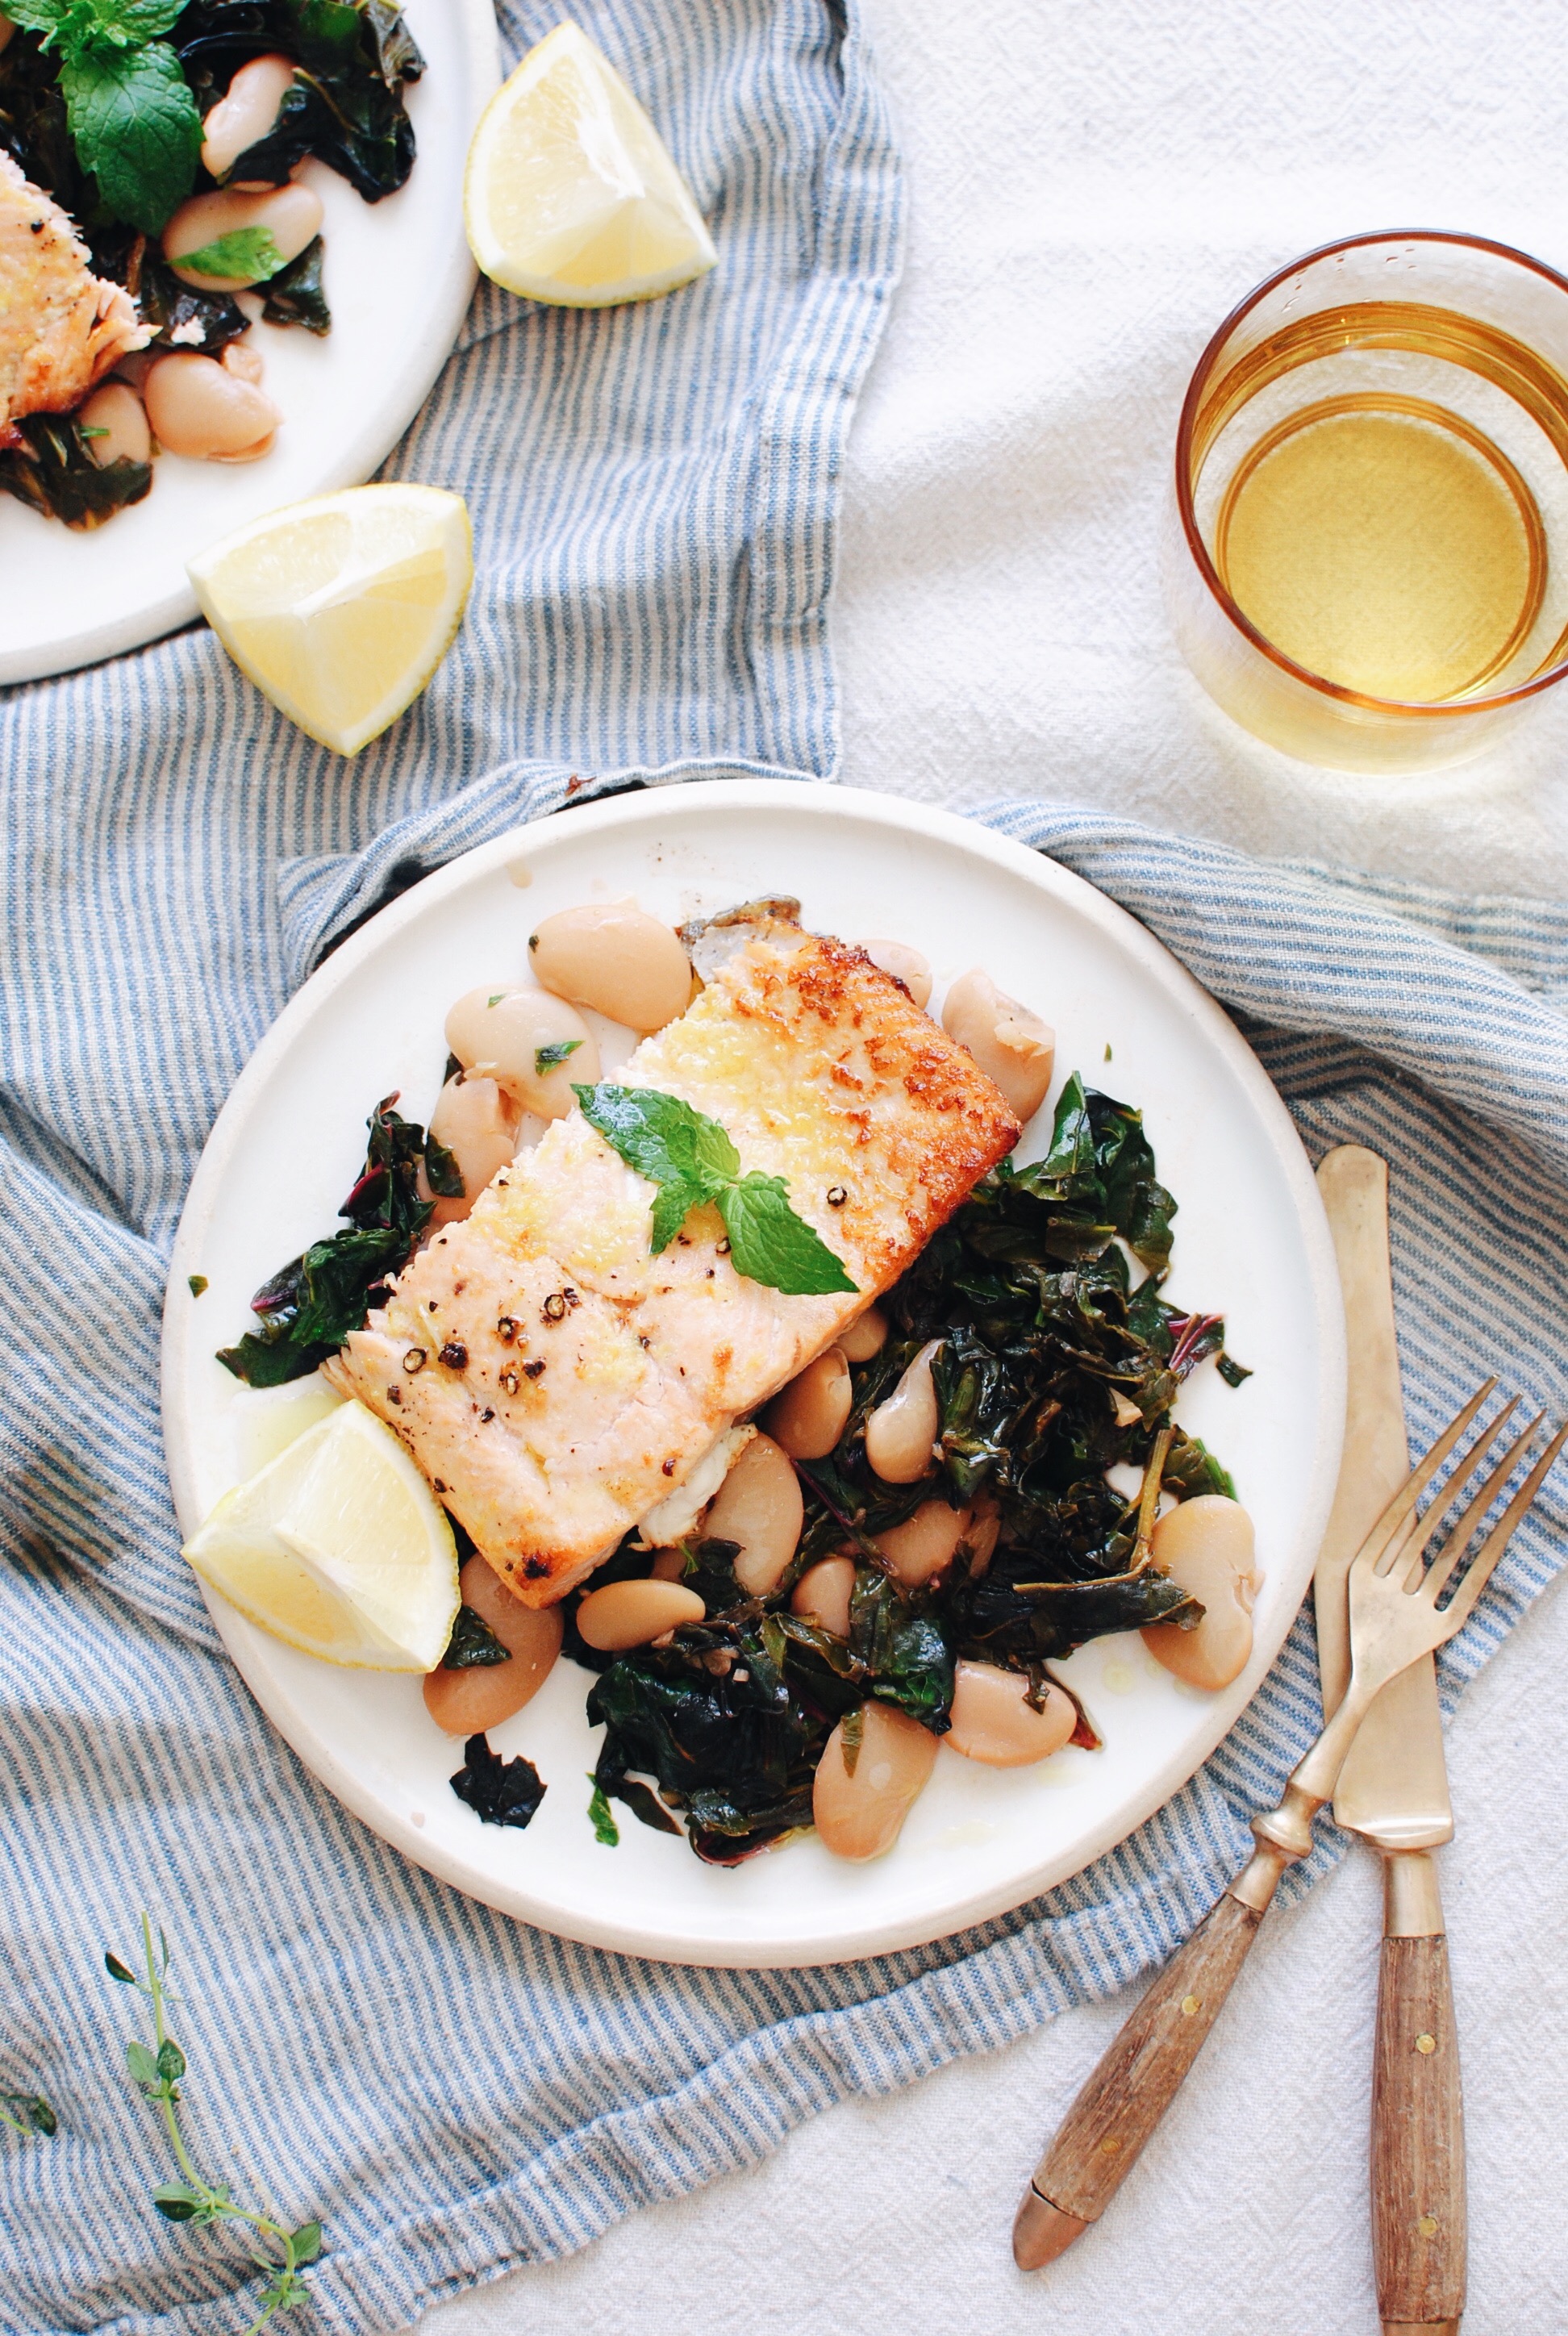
[217,1095,448,1387]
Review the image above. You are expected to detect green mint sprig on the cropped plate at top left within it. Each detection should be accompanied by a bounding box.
[5,0,201,236]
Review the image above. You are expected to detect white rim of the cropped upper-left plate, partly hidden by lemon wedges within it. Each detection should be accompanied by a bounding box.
[0,0,500,689]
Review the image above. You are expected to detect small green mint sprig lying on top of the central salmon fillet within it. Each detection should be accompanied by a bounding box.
[573,1079,857,1299]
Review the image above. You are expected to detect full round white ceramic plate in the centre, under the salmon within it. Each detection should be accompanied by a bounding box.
[164,782,1344,1965]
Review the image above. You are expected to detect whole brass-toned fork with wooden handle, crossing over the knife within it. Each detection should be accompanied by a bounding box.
[1011,1379,1568,2271]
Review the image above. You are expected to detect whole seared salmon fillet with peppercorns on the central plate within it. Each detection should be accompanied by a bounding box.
[327,918,1019,1605]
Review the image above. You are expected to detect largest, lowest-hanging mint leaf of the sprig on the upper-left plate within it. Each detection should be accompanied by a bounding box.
[60,40,201,236]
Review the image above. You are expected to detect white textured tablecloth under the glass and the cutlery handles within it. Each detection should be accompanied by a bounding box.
[423,0,1568,2336]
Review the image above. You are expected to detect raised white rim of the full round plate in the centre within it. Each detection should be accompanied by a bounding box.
[159,778,1346,1969]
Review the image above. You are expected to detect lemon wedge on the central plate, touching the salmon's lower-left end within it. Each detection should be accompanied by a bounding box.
[185,1404,461,1671]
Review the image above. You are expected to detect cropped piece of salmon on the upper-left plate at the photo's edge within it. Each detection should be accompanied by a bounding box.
[0,152,152,446]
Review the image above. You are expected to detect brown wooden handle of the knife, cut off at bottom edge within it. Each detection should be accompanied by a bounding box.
[1372,1915,1466,2336]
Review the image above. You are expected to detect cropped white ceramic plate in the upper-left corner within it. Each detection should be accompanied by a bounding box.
[0,0,500,682]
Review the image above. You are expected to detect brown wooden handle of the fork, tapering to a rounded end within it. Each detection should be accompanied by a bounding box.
[1011,1895,1261,2271]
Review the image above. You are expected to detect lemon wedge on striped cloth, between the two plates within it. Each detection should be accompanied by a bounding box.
[187,483,474,754]
